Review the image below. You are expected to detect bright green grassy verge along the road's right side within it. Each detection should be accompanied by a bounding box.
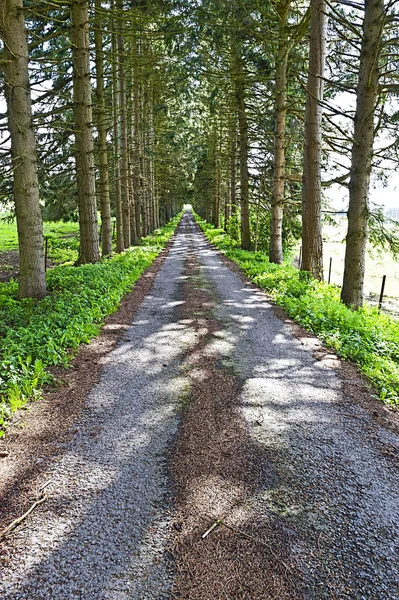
[196,216,399,406]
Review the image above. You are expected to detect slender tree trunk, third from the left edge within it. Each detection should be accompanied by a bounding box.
[94,0,112,256]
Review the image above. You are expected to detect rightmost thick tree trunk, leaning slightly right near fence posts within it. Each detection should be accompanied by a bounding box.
[341,0,384,309]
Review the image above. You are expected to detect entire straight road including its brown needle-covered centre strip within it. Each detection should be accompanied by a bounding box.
[0,213,399,600]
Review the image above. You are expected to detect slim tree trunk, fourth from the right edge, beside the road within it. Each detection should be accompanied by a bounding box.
[234,45,251,250]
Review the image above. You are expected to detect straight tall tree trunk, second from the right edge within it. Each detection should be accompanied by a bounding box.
[302,0,327,280]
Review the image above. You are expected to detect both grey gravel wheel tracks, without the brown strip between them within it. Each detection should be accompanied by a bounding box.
[0,214,399,600]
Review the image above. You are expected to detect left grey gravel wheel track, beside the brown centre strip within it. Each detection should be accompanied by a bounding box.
[0,224,193,600]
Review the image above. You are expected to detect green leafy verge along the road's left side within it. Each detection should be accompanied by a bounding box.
[0,217,179,436]
